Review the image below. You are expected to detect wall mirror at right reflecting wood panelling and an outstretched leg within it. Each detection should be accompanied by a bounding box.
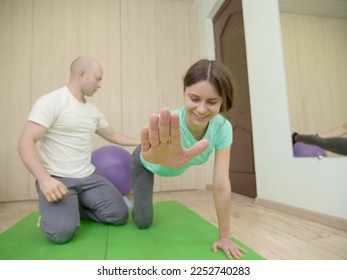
[279,0,347,157]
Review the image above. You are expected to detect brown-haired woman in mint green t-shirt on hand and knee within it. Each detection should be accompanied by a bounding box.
[131,59,247,259]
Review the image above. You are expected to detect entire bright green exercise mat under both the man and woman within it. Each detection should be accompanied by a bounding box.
[0,201,264,260]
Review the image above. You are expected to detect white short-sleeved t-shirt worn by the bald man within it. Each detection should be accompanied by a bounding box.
[28,87,108,178]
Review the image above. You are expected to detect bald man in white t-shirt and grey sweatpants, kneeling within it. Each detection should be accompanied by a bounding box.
[18,56,139,243]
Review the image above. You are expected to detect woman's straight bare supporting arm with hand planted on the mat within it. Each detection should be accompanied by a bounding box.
[212,146,247,259]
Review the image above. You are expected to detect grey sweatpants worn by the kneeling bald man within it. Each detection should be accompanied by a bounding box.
[36,172,128,243]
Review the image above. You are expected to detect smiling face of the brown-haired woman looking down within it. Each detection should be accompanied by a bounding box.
[184,81,222,130]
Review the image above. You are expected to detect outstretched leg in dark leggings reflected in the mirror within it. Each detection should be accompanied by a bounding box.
[295,134,347,156]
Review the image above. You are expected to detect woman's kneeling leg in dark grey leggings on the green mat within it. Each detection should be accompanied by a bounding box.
[131,145,154,229]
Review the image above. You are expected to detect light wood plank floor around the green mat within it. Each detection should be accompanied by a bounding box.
[0,190,347,260]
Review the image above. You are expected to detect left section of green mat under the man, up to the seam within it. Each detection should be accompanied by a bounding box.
[0,212,109,260]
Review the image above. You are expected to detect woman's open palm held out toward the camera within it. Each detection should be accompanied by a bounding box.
[141,108,209,168]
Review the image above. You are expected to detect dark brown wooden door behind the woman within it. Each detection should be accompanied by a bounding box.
[213,0,257,197]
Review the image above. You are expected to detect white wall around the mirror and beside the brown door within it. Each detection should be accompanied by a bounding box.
[196,0,347,219]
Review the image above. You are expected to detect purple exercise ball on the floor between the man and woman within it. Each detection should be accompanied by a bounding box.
[92,146,131,196]
